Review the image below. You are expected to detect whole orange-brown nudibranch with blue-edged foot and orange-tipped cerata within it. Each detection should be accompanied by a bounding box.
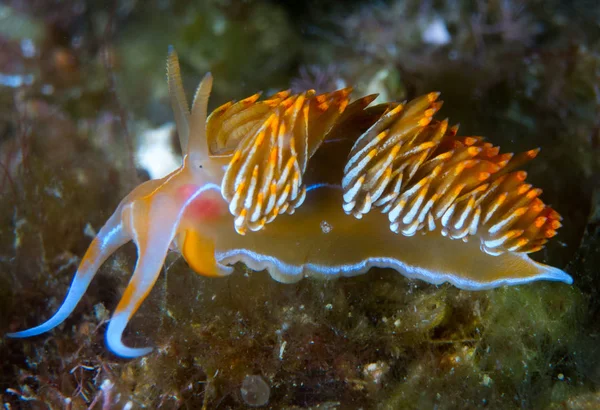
[9,49,572,358]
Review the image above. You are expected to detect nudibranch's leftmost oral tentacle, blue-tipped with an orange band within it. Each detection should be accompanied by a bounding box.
[6,207,131,338]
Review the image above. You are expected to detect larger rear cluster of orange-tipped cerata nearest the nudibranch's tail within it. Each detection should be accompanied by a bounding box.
[342,93,561,255]
